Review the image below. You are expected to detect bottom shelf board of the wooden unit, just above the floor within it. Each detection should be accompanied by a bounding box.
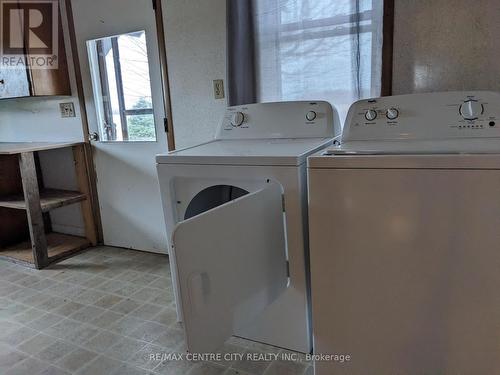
[0,232,90,266]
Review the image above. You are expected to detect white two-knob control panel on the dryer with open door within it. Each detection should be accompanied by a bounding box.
[216,101,341,139]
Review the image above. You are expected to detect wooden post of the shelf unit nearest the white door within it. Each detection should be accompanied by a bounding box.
[73,144,97,246]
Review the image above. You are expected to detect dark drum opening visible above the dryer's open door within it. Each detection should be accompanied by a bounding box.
[184,185,249,220]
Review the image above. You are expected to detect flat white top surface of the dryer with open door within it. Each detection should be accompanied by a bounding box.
[156,138,333,166]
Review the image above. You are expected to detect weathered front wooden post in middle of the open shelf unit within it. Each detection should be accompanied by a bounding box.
[19,152,48,269]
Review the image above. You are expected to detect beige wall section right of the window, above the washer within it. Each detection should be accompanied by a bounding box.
[393,0,500,94]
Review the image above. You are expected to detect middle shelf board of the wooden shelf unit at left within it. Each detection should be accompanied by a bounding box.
[0,189,86,212]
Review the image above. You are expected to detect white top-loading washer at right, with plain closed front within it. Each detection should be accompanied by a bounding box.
[308,91,500,375]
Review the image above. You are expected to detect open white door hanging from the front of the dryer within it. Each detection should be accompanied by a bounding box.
[173,184,288,353]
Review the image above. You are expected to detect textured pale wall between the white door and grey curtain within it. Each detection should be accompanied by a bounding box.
[162,0,226,148]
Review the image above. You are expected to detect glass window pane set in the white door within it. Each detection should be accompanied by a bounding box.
[88,31,156,141]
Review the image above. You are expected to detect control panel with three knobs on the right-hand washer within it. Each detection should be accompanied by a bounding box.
[342,91,500,142]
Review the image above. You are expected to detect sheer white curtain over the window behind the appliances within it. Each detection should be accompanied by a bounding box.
[253,0,383,122]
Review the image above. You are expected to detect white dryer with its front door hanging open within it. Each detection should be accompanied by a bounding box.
[156,102,340,352]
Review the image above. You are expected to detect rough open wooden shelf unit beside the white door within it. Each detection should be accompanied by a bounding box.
[0,142,97,269]
